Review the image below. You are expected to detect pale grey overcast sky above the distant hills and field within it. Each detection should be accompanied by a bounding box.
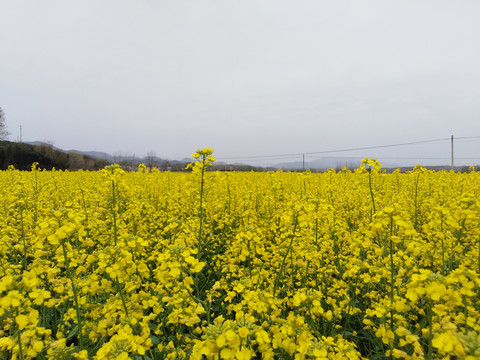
[0,0,480,167]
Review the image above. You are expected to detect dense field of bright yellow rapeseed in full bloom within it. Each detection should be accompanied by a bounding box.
[0,148,480,360]
